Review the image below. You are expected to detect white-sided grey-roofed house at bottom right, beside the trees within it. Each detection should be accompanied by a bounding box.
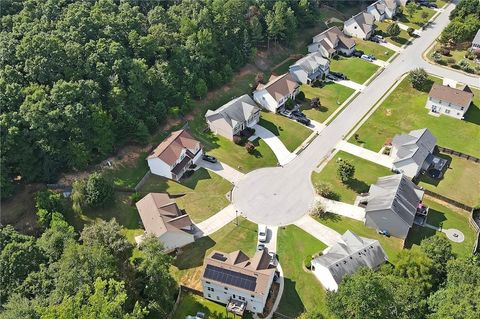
[312,230,388,291]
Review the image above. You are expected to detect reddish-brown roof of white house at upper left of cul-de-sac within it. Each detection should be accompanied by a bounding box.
[147,130,200,165]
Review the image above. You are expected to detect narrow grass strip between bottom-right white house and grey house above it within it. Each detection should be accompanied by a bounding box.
[315,213,403,263]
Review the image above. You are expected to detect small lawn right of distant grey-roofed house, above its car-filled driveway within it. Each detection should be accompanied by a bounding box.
[330,56,379,84]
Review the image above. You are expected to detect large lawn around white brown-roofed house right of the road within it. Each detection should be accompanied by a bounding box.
[350,77,480,157]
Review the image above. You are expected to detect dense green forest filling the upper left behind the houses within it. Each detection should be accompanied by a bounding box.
[0,0,319,198]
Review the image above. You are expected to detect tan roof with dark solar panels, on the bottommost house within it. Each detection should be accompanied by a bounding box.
[202,249,275,295]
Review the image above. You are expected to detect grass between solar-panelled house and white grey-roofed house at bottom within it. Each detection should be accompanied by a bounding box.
[277,225,328,318]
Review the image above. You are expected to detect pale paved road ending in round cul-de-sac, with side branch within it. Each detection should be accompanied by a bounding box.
[233,4,480,226]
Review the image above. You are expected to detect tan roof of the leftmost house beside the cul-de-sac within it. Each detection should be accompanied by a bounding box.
[136,193,192,237]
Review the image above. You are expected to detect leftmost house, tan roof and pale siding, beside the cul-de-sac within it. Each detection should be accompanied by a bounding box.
[135,193,195,251]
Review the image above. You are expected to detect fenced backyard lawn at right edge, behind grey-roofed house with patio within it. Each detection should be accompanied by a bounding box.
[419,153,480,207]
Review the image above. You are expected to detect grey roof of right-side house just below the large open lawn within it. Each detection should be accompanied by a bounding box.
[392,128,437,170]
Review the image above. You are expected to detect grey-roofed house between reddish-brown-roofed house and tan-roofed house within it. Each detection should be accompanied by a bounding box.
[205,94,260,140]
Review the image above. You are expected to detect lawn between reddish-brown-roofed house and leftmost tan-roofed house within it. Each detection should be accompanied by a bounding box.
[140,168,232,223]
